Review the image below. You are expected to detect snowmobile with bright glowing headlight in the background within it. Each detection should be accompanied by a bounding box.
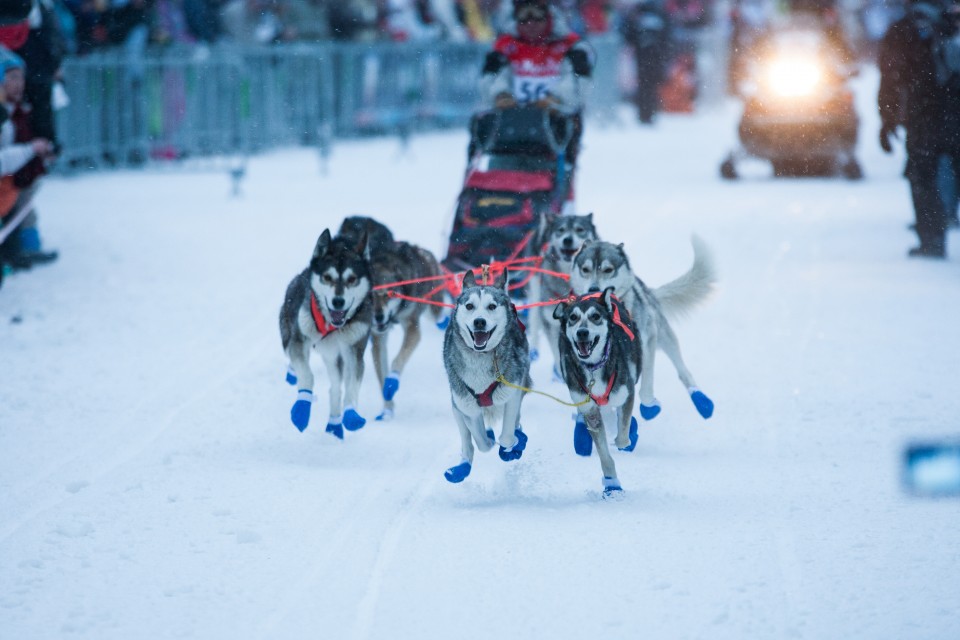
[720,25,863,180]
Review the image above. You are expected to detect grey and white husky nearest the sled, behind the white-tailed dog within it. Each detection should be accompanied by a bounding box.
[530,213,598,372]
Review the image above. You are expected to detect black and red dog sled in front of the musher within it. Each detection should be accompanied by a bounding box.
[443,106,576,271]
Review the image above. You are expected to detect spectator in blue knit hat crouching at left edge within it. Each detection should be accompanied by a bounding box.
[0,49,57,269]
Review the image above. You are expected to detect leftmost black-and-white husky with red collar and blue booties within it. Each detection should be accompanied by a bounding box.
[280,229,373,440]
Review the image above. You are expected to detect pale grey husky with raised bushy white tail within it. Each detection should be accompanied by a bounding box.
[570,236,716,420]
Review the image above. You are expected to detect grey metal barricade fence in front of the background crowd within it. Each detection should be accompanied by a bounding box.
[58,36,621,170]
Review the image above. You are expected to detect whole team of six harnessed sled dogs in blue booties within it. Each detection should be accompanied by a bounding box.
[280,214,716,497]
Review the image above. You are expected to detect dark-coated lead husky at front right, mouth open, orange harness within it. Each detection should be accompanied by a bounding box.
[553,287,642,497]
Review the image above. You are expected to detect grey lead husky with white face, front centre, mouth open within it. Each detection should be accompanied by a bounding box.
[443,271,531,482]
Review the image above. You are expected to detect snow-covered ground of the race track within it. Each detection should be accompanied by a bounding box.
[0,67,960,640]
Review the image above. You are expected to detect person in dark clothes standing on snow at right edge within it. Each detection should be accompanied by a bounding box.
[877,0,960,259]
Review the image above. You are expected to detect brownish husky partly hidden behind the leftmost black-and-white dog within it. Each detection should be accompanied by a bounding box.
[370,242,442,420]
